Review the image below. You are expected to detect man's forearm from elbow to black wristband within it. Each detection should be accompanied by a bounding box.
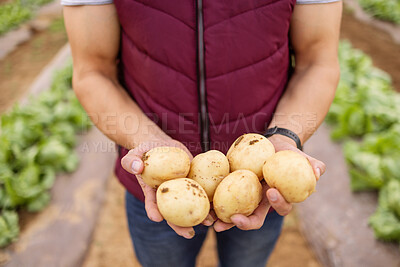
[269,62,339,147]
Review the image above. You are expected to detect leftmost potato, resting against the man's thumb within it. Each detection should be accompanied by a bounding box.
[141,146,190,188]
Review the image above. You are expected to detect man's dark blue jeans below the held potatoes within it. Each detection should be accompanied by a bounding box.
[126,192,283,267]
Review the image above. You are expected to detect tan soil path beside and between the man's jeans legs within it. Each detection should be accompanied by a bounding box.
[83,177,320,267]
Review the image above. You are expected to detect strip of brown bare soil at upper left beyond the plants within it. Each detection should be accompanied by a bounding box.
[0,17,67,113]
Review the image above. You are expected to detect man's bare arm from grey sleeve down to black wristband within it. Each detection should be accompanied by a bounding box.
[270,2,342,147]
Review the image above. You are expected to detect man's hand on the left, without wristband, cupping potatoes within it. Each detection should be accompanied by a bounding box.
[121,138,214,239]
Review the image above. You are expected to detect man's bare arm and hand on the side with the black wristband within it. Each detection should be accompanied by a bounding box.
[214,1,342,232]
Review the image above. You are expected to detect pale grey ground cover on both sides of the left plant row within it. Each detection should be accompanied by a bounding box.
[0,46,115,266]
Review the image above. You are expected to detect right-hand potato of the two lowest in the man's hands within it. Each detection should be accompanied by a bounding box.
[213,170,262,223]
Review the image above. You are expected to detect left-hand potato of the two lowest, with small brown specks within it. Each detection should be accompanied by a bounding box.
[157,178,210,227]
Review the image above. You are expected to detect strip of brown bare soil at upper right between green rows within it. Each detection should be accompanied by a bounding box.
[340,11,400,92]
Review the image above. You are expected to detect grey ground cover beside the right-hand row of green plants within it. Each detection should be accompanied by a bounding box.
[297,126,400,267]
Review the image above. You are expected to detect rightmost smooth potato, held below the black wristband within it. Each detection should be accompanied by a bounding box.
[263,150,317,203]
